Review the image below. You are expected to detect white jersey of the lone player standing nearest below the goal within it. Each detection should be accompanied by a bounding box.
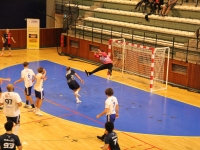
[105,96,118,115]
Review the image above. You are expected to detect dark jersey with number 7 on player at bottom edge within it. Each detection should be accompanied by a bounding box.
[105,132,120,150]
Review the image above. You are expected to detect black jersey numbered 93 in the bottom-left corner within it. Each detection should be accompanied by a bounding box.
[0,133,21,150]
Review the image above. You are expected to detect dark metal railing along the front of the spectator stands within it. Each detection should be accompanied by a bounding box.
[72,22,200,63]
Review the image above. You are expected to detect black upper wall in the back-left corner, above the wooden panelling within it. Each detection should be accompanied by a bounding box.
[0,0,46,29]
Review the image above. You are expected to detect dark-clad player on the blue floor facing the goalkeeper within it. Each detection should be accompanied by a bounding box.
[66,67,84,103]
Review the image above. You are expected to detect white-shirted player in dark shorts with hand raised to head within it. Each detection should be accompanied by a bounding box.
[34,67,47,116]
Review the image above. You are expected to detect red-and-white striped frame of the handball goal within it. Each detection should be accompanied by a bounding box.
[108,38,170,92]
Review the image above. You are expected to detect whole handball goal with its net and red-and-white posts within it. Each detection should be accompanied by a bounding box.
[108,39,170,92]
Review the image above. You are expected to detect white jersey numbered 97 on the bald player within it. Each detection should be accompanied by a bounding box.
[0,92,22,117]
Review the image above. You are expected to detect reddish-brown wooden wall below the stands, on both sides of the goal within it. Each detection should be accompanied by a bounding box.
[63,36,200,90]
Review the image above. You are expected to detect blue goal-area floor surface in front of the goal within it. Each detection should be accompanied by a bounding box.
[0,60,200,136]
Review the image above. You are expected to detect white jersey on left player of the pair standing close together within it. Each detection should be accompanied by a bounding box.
[21,68,35,88]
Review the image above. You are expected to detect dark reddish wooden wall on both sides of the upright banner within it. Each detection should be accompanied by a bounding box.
[0,28,63,49]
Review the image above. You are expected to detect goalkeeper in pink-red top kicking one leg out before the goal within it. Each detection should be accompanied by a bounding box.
[85,49,113,79]
